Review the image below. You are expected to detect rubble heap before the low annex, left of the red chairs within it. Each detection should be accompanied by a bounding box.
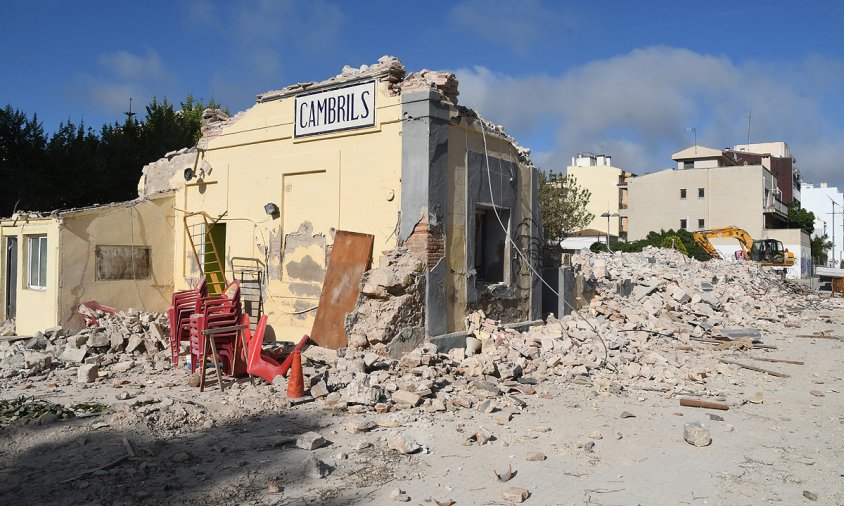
[0,306,170,383]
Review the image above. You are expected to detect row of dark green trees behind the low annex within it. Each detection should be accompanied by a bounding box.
[0,95,219,216]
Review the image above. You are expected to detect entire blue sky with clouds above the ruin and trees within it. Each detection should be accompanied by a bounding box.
[0,0,844,188]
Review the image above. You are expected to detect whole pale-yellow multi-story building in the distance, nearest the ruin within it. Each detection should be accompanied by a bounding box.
[566,153,635,239]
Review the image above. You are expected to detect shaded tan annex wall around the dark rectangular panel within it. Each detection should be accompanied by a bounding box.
[57,194,174,331]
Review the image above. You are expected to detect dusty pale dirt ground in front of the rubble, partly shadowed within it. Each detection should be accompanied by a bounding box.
[0,304,844,505]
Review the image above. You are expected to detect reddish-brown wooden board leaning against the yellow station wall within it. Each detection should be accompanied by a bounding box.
[311,230,375,350]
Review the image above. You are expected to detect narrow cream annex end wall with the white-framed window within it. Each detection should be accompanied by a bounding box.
[0,218,61,335]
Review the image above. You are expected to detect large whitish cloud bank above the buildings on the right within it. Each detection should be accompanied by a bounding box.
[456,46,844,186]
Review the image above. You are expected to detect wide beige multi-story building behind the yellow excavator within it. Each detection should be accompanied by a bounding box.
[621,146,810,277]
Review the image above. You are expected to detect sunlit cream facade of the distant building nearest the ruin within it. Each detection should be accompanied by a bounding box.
[566,165,622,237]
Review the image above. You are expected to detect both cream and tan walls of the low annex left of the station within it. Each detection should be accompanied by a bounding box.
[0,194,174,335]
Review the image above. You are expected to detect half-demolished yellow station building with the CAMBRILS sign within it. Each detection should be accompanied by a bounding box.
[1,57,541,340]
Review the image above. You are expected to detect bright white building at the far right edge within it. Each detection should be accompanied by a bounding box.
[802,181,844,267]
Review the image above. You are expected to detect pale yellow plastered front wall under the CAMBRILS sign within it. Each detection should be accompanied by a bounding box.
[172,82,402,340]
